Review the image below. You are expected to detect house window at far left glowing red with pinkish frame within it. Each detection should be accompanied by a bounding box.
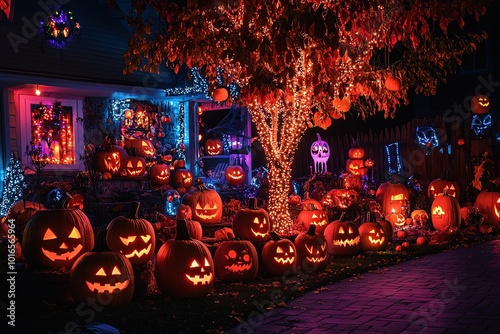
[19,96,83,171]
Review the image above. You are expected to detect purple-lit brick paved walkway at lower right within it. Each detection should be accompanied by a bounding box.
[229,240,500,334]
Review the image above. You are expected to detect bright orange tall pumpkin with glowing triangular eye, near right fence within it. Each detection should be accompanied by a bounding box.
[431,195,462,231]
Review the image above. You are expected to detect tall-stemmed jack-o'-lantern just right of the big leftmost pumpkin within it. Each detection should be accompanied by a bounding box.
[106,202,156,265]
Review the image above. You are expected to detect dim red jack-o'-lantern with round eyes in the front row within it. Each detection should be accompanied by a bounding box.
[214,240,259,282]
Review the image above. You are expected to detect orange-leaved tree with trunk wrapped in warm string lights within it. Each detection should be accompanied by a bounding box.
[124,0,488,230]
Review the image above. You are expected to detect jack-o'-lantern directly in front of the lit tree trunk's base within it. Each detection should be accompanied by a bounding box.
[261,231,297,276]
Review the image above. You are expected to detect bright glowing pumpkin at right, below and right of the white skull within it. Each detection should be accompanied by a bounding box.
[375,182,410,216]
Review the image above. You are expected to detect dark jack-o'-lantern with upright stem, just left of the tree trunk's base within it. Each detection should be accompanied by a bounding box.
[233,198,271,243]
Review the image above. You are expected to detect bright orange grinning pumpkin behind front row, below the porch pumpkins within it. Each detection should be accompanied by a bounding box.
[182,179,222,224]
